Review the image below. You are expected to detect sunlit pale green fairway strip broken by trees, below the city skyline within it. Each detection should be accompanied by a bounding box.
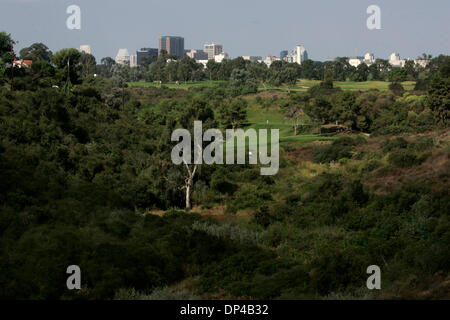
[128,79,415,91]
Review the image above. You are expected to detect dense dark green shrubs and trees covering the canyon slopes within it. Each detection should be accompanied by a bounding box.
[0,34,450,299]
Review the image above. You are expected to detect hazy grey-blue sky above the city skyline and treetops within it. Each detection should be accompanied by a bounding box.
[0,0,450,60]
